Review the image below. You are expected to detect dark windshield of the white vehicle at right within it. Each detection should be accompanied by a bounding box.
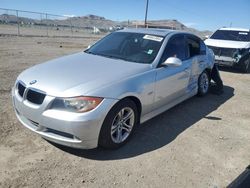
[210,30,250,42]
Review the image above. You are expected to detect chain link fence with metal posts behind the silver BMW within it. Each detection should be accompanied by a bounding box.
[0,8,119,37]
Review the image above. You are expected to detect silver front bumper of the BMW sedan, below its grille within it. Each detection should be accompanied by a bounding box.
[12,87,117,149]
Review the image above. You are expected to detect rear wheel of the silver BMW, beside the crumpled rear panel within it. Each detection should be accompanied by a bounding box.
[197,71,210,97]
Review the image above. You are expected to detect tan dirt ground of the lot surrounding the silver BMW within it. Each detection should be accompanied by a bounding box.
[0,36,250,188]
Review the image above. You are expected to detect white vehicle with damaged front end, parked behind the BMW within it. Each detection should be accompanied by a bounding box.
[205,28,250,72]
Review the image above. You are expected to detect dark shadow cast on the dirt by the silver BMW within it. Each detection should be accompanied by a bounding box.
[52,86,234,160]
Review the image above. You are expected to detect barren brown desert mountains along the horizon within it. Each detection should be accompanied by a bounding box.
[0,14,211,37]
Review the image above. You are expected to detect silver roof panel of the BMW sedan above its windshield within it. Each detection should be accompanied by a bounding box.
[117,28,190,37]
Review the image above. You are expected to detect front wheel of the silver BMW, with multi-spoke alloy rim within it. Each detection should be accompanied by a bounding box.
[98,99,138,149]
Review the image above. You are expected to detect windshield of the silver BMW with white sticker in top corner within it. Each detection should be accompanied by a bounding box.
[85,32,163,64]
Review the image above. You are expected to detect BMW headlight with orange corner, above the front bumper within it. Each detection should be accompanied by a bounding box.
[51,97,103,113]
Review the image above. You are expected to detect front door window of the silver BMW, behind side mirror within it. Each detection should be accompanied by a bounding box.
[162,35,187,62]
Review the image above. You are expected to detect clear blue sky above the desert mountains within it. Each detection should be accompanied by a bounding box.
[0,0,250,31]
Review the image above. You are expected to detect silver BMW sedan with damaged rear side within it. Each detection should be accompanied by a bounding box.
[12,29,214,149]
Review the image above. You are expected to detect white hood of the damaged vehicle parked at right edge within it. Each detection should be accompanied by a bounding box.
[205,39,250,48]
